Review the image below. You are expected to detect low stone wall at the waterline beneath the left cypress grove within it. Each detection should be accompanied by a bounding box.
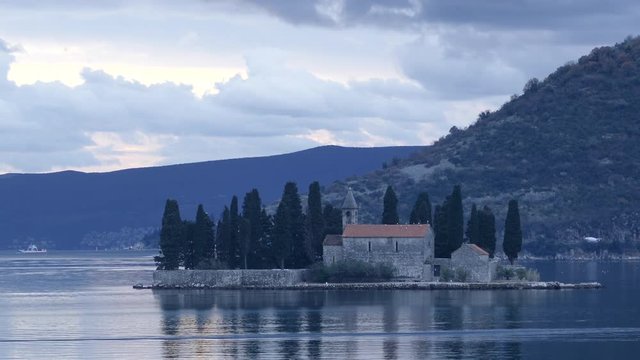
[153,269,306,288]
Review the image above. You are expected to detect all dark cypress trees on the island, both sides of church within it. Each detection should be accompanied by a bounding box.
[154,181,522,270]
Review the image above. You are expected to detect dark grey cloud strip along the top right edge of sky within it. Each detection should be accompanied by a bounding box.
[238,0,640,32]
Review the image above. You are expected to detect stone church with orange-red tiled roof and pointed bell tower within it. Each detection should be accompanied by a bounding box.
[323,189,434,281]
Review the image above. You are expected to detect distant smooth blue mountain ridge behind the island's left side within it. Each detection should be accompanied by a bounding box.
[0,146,420,248]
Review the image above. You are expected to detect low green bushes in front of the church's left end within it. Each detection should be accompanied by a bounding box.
[309,260,395,283]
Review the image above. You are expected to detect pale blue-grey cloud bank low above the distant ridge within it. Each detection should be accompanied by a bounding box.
[0,41,443,172]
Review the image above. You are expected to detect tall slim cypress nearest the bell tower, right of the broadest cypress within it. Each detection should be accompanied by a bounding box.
[305,181,324,262]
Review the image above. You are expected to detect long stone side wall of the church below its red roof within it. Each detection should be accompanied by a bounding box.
[342,237,430,279]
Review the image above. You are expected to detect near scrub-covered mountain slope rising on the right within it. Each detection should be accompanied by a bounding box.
[325,38,640,253]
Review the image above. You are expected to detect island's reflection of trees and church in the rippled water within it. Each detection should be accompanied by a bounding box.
[153,290,537,359]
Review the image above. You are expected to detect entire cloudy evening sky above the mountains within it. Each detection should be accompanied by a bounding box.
[0,0,640,173]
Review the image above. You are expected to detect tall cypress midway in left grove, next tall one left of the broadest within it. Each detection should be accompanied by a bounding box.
[242,189,264,268]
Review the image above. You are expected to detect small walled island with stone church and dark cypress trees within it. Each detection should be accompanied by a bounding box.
[134,182,602,290]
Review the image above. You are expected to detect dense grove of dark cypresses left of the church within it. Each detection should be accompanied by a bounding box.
[154,182,342,270]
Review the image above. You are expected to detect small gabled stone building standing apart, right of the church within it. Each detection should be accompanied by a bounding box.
[451,243,497,282]
